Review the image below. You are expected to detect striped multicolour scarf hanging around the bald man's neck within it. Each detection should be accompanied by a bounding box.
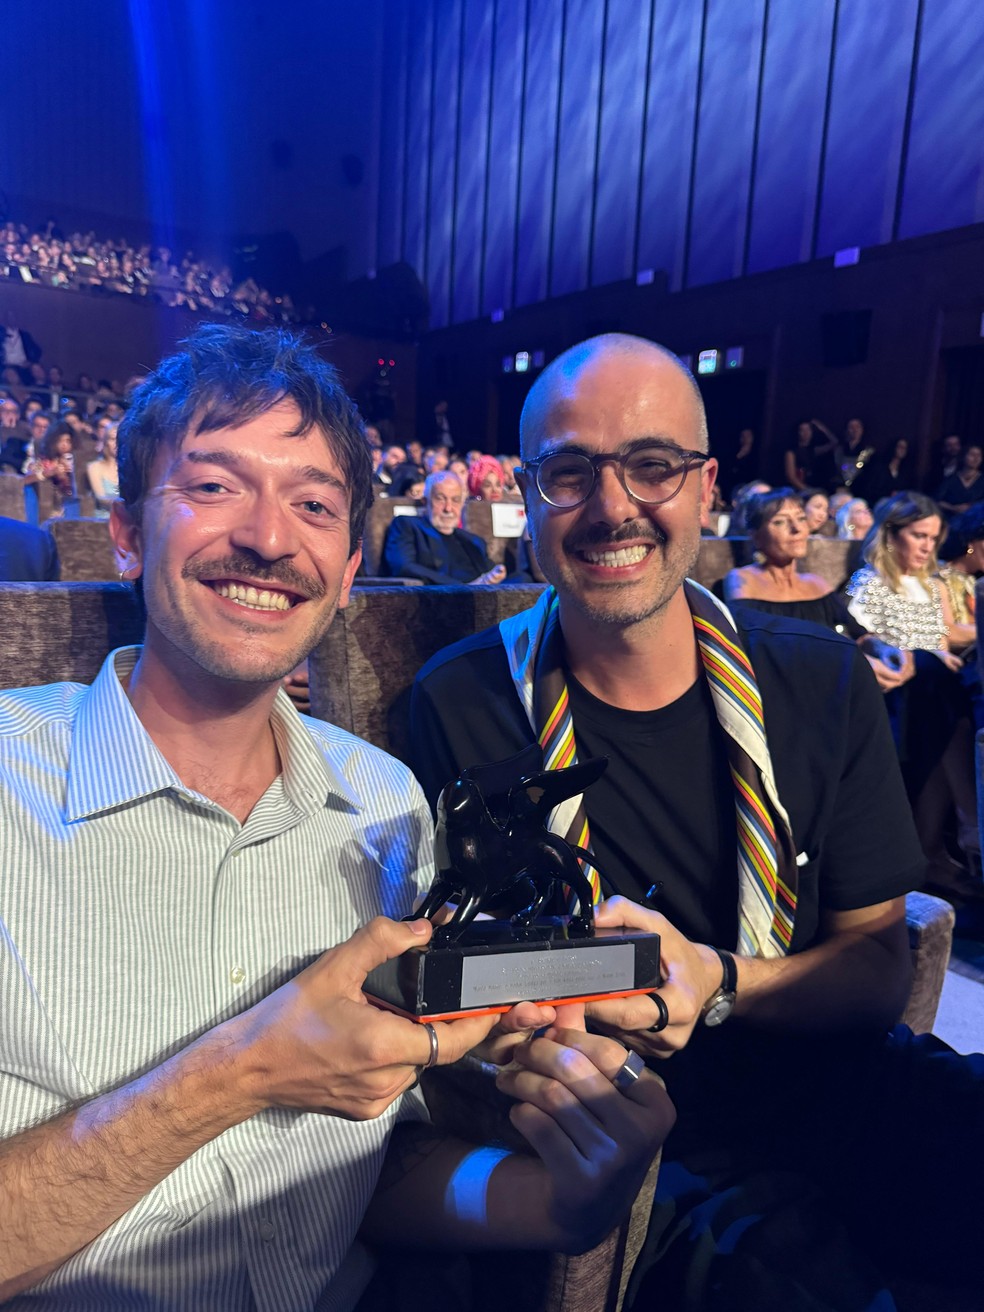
[499,579,796,956]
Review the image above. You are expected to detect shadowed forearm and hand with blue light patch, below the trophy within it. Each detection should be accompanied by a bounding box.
[363,1029,676,1253]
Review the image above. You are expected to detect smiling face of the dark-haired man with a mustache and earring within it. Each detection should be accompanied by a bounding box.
[110,401,361,684]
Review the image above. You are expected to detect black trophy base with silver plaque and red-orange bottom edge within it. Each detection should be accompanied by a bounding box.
[363,917,660,1021]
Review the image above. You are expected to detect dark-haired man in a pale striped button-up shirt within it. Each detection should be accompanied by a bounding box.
[0,324,672,1312]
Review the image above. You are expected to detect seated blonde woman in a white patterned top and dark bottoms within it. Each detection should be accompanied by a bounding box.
[848,492,980,896]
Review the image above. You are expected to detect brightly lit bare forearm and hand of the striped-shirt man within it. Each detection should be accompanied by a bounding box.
[0,917,496,1299]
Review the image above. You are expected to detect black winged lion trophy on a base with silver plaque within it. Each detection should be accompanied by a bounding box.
[365,744,660,1021]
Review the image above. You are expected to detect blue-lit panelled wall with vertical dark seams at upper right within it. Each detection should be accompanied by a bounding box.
[377,0,984,327]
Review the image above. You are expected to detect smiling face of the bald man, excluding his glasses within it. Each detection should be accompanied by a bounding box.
[520,346,716,626]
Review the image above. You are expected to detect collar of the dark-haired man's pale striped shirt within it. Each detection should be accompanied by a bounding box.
[66,647,362,823]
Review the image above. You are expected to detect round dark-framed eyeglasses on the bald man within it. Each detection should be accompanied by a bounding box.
[521,443,710,510]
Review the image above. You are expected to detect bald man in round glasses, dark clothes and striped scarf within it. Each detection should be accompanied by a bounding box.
[411,335,984,1312]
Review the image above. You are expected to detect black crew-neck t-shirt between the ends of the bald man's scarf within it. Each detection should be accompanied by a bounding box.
[568,676,737,943]
